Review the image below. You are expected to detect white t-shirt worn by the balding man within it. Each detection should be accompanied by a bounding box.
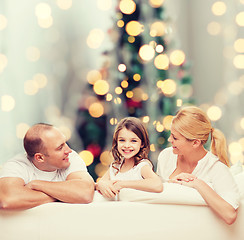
[0,151,87,184]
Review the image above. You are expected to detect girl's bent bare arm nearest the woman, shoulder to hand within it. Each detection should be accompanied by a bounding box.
[114,165,163,193]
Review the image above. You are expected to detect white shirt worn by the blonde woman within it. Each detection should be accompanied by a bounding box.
[157,147,239,209]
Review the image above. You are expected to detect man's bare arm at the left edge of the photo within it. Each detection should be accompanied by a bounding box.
[0,177,56,210]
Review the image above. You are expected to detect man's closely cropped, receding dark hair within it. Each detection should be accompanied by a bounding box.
[24,123,53,160]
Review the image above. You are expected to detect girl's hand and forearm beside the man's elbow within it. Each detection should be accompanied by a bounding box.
[95,170,118,198]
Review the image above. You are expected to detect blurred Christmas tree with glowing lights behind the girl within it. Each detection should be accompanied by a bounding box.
[75,0,193,178]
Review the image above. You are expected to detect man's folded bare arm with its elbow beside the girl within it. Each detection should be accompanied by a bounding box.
[26,171,94,203]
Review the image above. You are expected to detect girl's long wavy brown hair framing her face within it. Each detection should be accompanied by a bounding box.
[111,117,150,172]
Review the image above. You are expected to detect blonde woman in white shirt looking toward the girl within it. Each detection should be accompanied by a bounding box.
[157,106,239,224]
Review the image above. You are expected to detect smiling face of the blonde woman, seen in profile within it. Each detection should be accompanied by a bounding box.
[168,127,192,155]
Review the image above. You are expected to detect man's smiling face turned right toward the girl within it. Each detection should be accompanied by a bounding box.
[41,128,71,172]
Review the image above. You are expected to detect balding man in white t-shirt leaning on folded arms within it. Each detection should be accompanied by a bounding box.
[0,123,94,209]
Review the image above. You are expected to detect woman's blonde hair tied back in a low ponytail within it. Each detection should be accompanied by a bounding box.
[172,106,229,166]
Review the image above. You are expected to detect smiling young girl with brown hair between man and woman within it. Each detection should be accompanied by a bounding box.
[96,117,163,198]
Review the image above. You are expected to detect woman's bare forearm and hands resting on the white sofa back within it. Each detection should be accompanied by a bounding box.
[171,173,237,225]
